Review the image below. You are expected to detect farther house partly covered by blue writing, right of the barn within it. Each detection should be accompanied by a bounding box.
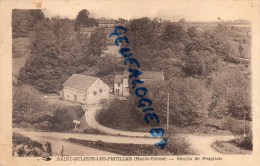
[114,71,164,96]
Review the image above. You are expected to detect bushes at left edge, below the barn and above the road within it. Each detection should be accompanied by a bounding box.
[13,85,84,132]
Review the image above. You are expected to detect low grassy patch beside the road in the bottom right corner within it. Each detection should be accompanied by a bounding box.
[211,141,252,154]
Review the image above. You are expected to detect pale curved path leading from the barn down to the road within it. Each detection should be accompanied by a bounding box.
[83,105,151,137]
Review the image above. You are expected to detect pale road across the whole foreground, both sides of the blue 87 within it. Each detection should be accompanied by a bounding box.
[13,128,234,156]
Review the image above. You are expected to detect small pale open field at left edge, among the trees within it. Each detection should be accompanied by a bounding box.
[12,38,31,76]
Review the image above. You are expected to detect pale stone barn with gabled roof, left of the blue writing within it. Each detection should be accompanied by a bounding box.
[61,74,109,105]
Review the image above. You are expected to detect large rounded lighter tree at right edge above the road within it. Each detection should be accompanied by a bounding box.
[211,68,251,120]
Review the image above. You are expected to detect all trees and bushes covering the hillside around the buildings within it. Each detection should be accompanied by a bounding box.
[12,10,252,152]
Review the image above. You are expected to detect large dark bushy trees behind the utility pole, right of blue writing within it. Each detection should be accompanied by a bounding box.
[146,78,211,126]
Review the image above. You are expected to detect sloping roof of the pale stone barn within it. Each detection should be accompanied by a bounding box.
[63,74,98,90]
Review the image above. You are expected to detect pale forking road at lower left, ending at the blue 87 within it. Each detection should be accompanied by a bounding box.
[13,128,159,156]
